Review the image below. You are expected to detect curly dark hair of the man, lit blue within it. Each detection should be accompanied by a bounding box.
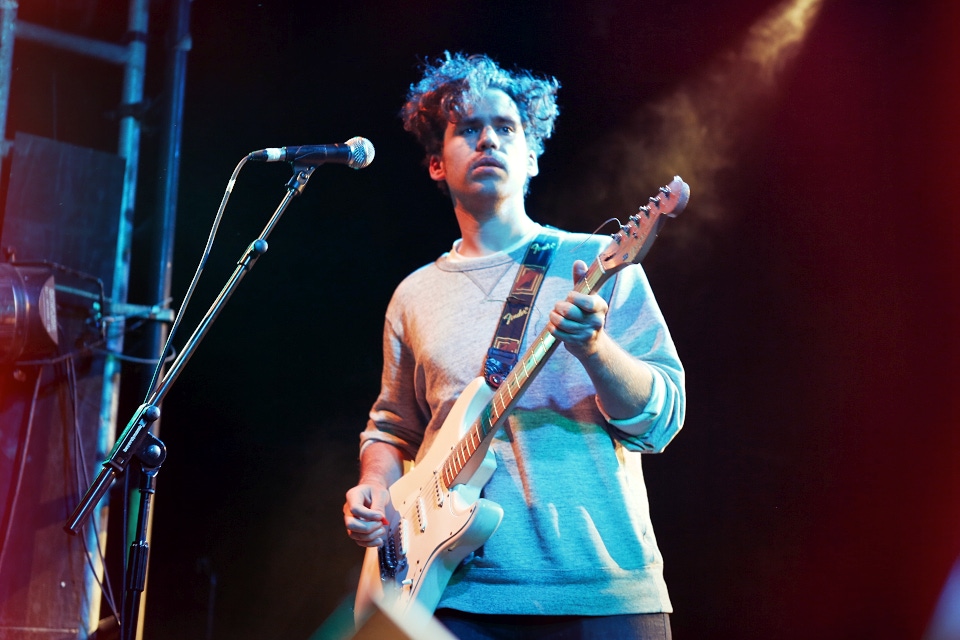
[400,51,560,159]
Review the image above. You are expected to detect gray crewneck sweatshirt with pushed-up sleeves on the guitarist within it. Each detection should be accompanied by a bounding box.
[361,225,686,615]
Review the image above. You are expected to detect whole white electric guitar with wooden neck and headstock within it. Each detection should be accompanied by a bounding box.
[354,176,690,624]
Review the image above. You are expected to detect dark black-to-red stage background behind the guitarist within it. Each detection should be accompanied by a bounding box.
[1,0,960,640]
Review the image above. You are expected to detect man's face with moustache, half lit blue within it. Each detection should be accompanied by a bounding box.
[430,89,538,203]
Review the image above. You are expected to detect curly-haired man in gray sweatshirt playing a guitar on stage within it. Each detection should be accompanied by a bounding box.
[344,54,686,639]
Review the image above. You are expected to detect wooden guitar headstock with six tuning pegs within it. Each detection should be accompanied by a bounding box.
[597,176,690,273]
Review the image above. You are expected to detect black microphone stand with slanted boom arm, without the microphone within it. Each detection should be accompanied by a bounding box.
[64,163,317,640]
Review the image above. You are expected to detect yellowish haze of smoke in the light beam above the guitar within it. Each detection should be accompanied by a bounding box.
[550,0,822,260]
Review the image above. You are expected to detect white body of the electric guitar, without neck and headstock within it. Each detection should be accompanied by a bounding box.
[354,378,503,624]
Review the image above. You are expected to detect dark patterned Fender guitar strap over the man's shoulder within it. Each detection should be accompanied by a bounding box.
[483,233,557,389]
